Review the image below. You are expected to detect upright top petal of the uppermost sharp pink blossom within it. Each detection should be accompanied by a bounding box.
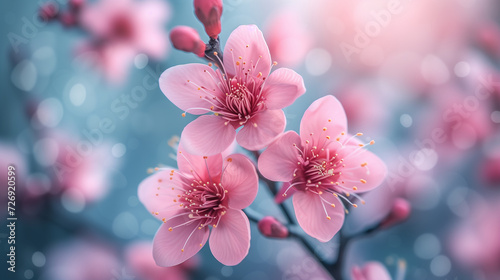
[224,25,271,77]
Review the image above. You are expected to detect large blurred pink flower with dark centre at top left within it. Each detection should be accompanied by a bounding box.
[80,0,170,82]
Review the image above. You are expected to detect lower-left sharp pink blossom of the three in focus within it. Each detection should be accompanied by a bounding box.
[139,145,258,267]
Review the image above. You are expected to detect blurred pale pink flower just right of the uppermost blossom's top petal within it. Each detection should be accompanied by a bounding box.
[265,9,313,67]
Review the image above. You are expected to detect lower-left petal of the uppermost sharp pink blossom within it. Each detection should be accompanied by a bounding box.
[180,115,236,156]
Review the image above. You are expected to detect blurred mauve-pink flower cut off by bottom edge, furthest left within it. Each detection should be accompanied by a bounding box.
[41,240,120,280]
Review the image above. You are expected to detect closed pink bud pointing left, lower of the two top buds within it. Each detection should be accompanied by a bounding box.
[170,26,205,57]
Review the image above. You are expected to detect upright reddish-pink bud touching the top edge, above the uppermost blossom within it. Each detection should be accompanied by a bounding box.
[194,0,222,39]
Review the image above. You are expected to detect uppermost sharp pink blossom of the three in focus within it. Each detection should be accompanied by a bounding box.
[160,25,305,155]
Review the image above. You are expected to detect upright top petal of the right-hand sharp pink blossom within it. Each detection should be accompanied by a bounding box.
[300,95,347,146]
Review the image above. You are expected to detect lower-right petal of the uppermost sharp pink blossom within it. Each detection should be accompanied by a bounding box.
[236,110,286,151]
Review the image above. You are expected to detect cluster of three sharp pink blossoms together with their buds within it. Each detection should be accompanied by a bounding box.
[139,1,387,266]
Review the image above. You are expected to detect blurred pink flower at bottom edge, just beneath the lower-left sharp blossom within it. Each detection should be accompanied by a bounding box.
[125,241,198,280]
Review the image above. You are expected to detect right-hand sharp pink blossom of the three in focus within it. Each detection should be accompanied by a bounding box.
[258,95,387,242]
